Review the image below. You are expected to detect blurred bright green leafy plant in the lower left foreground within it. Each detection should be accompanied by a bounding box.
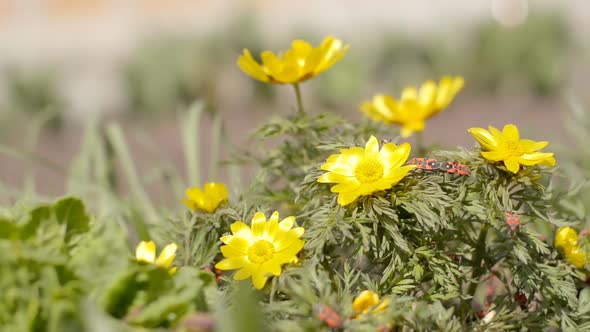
[0,197,214,331]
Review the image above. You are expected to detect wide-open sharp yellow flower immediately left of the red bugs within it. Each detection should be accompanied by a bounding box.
[318,136,416,206]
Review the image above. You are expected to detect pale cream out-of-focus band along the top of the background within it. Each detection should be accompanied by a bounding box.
[0,0,590,115]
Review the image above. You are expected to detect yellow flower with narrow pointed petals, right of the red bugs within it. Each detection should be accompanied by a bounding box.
[468,124,555,174]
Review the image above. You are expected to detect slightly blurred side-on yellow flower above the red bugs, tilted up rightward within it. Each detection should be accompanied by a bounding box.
[361,76,464,137]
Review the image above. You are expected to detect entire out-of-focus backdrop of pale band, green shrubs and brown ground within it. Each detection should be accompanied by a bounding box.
[0,0,590,200]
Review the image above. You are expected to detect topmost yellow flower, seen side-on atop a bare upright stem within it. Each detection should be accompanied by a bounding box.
[238,36,349,84]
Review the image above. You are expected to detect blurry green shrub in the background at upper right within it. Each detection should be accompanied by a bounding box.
[469,12,573,95]
